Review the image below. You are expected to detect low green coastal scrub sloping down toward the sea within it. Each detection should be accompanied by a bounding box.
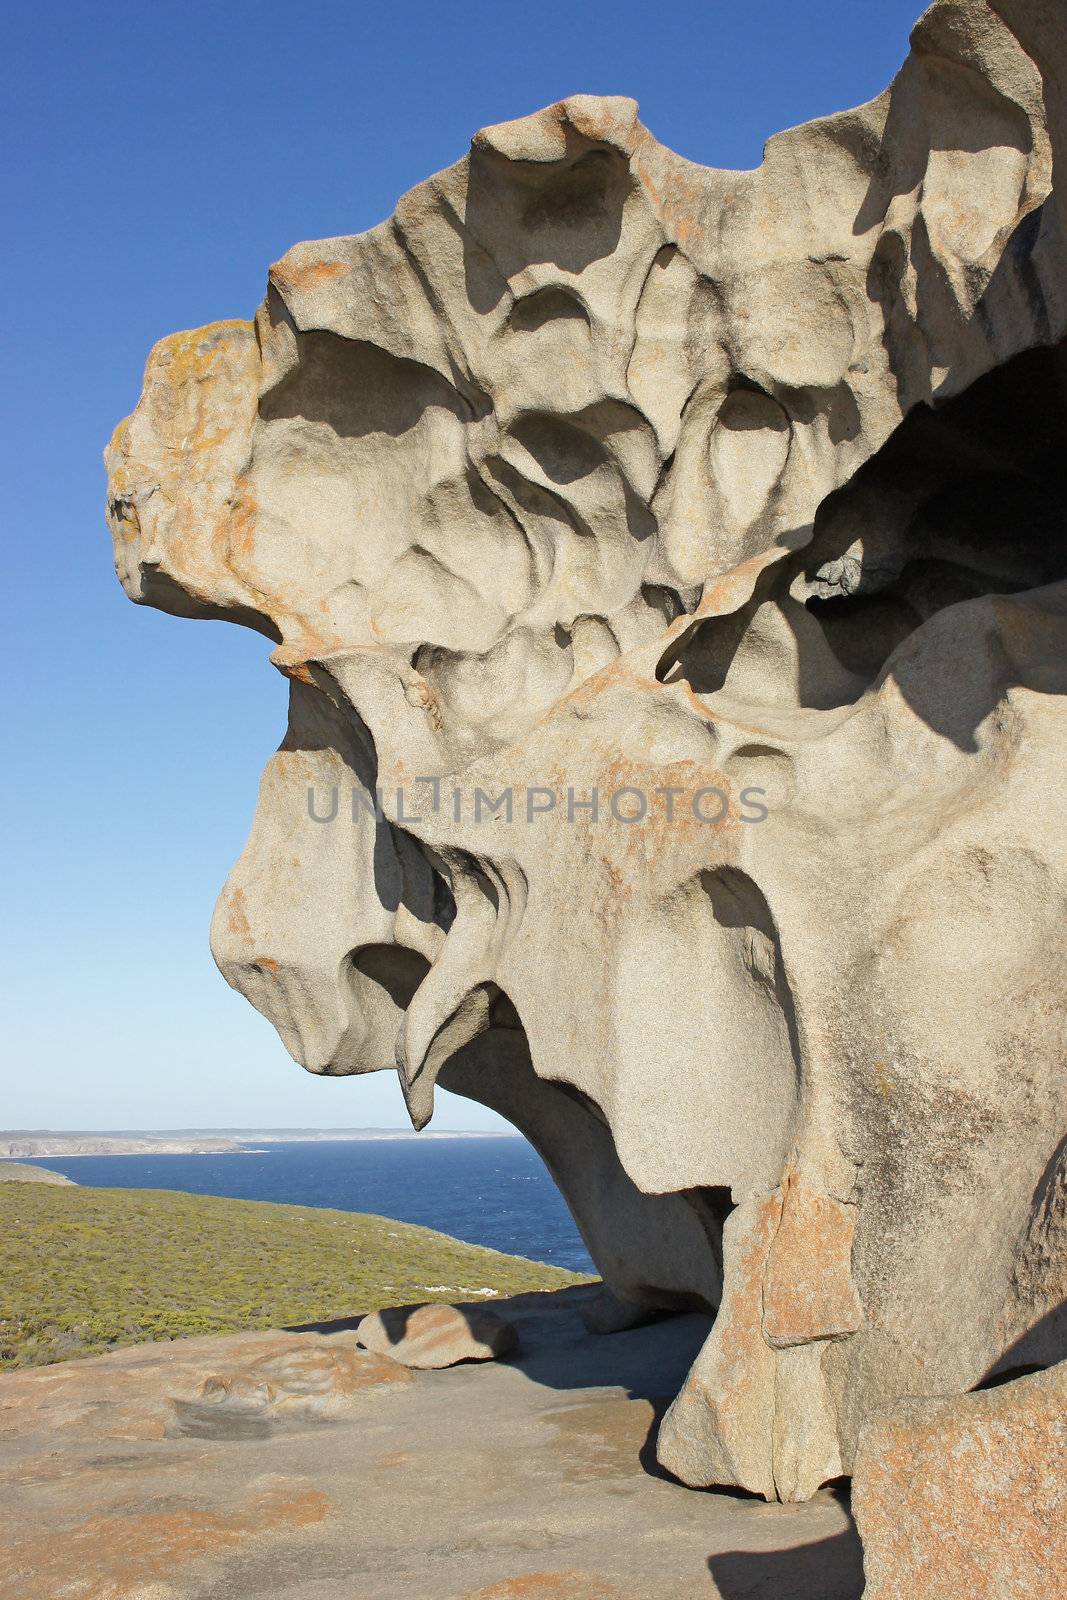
[0,1182,587,1368]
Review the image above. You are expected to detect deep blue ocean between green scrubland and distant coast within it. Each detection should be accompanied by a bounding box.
[18,1138,595,1272]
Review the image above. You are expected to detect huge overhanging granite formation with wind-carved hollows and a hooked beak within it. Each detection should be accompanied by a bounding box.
[107,0,1067,1499]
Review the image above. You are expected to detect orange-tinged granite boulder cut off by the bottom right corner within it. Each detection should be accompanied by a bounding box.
[853,1363,1067,1600]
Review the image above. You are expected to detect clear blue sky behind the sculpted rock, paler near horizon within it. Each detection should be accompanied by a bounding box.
[0,0,920,1128]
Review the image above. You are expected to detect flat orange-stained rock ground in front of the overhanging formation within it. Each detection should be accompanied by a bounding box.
[0,1286,862,1600]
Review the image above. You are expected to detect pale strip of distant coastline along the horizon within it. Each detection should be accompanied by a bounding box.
[0,1128,518,1160]
